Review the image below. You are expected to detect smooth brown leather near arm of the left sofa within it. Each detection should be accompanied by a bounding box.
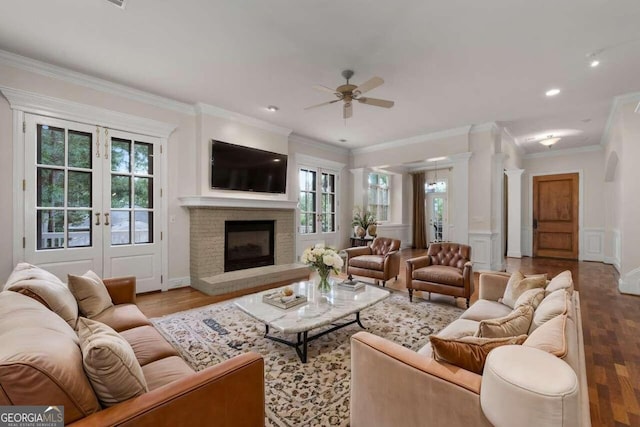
[70,353,265,427]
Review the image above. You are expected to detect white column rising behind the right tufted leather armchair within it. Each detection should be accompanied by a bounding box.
[449,152,472,245]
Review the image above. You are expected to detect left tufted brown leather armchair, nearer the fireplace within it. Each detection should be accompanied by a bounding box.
[345,237,400,286]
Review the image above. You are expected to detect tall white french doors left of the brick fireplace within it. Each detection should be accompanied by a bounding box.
[23,114,162,292]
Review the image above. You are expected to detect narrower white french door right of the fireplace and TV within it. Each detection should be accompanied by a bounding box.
[296,166,340,259]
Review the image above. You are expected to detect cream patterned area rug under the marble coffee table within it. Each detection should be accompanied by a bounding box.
[152,292,464,427]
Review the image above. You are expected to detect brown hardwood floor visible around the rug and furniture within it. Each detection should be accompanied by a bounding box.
[138,249,640,426]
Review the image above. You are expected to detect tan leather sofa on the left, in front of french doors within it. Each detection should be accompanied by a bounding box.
[0,264,264,426]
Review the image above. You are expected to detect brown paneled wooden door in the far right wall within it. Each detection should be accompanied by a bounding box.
[533,173,579,259]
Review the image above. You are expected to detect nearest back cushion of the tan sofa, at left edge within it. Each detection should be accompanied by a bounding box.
[0,291,100,424]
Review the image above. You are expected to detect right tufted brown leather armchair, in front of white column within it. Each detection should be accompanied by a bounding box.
[405,243,473,307]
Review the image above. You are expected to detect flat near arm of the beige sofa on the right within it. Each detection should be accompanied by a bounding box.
[350,332,489,427]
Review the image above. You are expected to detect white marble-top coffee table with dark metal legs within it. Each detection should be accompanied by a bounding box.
[235,280,390,363]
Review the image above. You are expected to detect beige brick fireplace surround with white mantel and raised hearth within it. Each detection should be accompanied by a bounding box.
[180,196,308,295]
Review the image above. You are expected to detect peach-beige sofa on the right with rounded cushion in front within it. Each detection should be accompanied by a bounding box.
[350,272,591,427]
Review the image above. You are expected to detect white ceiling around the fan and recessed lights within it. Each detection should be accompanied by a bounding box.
[0,0,640,153]
